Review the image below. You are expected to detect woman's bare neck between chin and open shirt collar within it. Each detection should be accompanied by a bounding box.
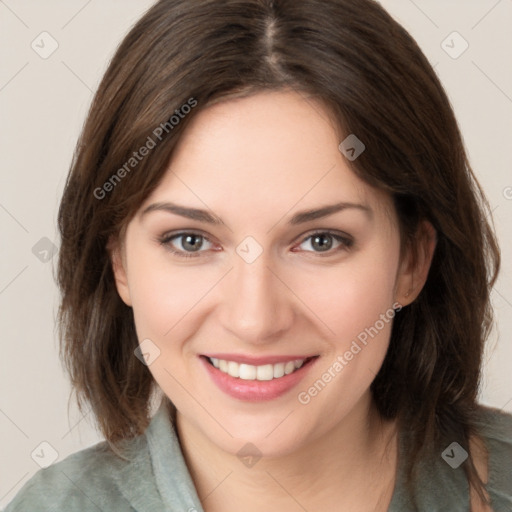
[176,393,398,512]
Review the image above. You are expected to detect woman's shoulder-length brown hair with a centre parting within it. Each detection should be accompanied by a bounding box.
[58,0,500,504]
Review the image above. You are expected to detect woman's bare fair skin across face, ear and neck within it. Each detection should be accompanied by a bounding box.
[112,91,435,512]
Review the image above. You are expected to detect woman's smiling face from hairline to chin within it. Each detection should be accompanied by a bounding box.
[114,92,418,455]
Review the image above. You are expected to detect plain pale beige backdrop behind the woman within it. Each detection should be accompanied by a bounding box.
[0,0,512,507]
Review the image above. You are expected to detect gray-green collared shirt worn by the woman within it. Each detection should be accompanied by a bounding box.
[6,403,512,512]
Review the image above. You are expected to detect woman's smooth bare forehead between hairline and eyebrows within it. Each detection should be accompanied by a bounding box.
[143,91,396,227]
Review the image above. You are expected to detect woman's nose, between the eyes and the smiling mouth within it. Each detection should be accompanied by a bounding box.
[220,252,294,344]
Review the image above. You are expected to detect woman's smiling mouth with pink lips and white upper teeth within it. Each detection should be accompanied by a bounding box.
[200,354,319,401]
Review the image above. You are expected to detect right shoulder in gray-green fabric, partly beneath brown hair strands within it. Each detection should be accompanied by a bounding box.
[389,406,512,512]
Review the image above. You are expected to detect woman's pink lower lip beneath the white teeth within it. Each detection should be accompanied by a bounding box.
[200,356,318,402]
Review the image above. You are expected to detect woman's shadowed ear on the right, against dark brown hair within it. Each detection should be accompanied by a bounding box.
[395,220,437,306]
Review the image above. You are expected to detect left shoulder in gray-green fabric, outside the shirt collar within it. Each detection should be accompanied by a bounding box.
[6,436,147,512]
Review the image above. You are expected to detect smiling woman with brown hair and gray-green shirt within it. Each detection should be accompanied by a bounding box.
[7,0,512,512]
